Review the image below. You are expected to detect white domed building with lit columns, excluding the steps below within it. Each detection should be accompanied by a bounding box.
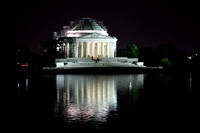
[54,17,117,59]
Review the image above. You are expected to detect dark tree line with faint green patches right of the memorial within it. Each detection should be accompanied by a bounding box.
[118,43,200,70]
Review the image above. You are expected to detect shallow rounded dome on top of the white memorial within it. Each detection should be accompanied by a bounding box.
[69,17,107,31]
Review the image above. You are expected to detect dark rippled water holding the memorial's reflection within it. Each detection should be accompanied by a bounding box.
[15,73,199,132]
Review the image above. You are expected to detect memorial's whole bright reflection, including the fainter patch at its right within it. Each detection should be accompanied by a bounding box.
[56,74,144,122]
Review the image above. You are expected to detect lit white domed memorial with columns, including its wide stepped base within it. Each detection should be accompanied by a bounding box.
[42,17,143,69]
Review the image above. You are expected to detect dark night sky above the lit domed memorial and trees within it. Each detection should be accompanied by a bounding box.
[13,0,200,53]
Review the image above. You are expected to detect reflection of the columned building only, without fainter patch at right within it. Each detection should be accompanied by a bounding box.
[56,75,117,121]
